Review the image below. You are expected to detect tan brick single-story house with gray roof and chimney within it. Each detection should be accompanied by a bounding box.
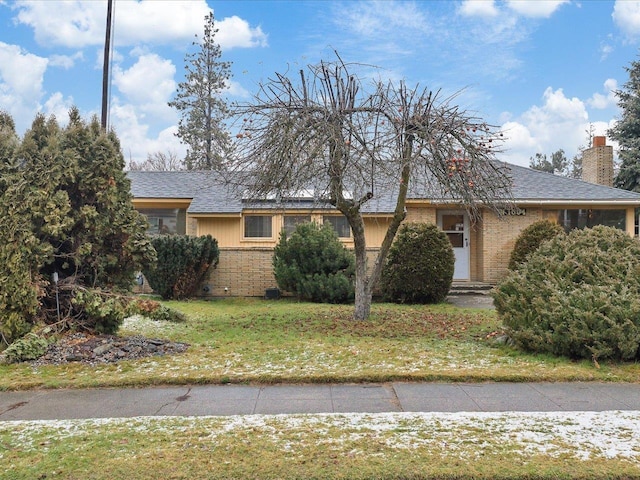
[128,137,640,297]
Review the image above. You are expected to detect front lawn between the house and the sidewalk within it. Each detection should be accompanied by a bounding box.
[0,299,640,390]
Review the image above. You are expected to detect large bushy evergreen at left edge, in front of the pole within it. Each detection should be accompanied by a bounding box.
[0,109,155,343]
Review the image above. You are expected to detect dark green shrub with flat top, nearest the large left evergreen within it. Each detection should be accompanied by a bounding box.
[143,235,220,300]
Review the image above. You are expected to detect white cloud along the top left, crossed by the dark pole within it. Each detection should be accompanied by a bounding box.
[14,0,266,49]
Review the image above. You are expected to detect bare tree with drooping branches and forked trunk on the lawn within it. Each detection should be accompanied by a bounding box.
[229,58,511,320]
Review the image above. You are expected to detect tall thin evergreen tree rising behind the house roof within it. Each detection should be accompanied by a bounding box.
[169,13,231,170]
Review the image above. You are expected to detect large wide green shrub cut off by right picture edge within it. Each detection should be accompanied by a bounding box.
[492,226,640,360]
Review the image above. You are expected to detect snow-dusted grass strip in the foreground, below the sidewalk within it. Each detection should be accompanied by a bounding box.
[0,412,640,480]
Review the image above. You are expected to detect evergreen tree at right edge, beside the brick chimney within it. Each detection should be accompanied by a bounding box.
[607,55,640,192]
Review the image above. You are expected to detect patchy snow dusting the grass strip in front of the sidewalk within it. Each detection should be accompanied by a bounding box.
[0,411,640,465]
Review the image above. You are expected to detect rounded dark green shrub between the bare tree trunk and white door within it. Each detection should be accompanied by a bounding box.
[380,223,455,303]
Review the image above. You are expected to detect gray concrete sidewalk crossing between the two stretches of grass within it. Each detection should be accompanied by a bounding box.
[0,382,640,421]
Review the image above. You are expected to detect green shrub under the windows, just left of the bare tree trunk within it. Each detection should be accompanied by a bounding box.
[273,222,355,303]
